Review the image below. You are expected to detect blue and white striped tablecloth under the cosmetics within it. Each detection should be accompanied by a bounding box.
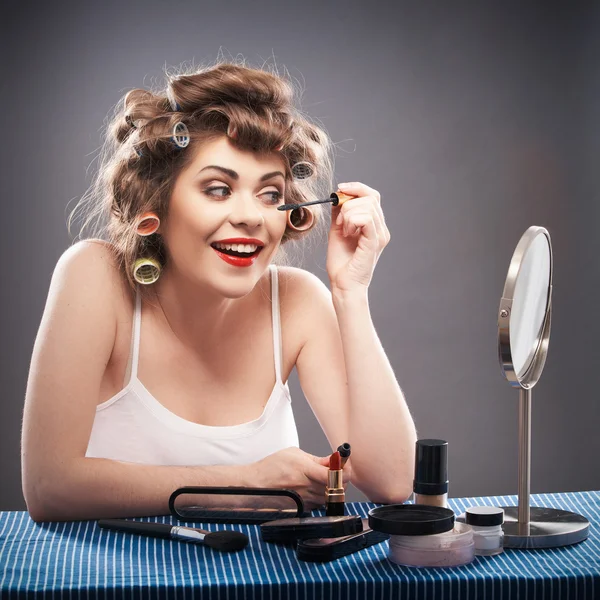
[0,492,600,600]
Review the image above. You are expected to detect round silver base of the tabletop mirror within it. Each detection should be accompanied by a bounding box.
[502,506,590,548]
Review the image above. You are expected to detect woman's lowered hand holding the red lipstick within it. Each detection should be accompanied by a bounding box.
[254,447,352,510]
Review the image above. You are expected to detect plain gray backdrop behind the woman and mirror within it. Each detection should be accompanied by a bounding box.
[0,0,600,510]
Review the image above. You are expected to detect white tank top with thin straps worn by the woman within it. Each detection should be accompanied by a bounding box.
[86,265,299,466]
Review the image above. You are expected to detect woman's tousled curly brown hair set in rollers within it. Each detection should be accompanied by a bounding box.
[68,61,333,298]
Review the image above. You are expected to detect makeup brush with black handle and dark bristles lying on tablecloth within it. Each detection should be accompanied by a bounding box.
[98,519,248,552]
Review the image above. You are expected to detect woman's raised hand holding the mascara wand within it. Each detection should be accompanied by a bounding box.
[327,182,391,293]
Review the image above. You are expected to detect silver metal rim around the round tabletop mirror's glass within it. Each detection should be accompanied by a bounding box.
[498,225,554,389]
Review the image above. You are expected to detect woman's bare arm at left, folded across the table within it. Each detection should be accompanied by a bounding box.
[22,242,326,521]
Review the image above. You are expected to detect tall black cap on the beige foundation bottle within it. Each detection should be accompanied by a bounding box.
[413,440,448,496]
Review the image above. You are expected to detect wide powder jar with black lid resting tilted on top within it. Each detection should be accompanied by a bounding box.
[369,504,475,567]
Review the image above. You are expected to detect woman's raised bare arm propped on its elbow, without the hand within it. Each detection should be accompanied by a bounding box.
[294,271,416,503]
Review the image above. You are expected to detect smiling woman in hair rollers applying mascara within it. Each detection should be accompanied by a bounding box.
[22,63,416,521]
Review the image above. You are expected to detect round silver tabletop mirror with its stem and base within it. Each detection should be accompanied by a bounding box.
[498,226,589,548]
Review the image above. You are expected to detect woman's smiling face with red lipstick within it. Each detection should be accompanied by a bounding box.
[159,136,287,297]
